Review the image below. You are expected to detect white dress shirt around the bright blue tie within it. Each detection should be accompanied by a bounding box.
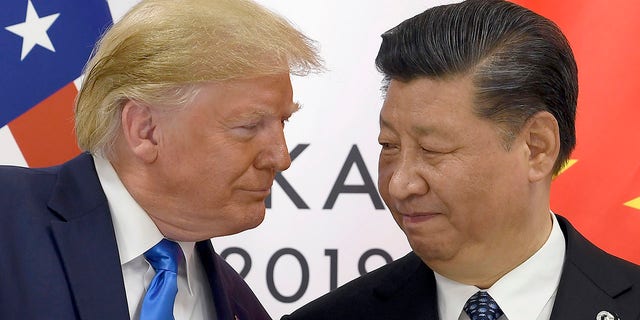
[93,155,215,320]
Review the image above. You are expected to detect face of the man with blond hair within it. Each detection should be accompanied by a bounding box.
[123,73,298,241]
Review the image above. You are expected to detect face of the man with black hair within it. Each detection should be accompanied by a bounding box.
[378,77,536,276]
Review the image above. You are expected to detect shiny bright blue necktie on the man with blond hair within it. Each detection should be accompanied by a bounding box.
[140,239,182,320]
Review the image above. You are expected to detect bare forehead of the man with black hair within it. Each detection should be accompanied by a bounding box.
[380,77,479,133]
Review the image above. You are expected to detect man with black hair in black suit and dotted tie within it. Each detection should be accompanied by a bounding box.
[285,0,640,320]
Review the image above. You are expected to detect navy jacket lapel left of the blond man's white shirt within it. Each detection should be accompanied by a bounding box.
[49,154,129,319]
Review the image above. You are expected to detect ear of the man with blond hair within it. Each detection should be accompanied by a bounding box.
[122,100,158,163]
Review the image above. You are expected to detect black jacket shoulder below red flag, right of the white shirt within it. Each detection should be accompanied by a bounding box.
[551,216,640,320]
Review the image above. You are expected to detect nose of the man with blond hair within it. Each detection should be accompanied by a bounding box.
[255,126,291,171]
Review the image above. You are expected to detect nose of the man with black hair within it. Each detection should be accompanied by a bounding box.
[381,155,429,200]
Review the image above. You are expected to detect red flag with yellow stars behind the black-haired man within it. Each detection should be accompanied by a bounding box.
[514,0,640,264]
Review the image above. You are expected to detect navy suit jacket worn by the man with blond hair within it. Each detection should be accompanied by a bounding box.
[0,154,270,320]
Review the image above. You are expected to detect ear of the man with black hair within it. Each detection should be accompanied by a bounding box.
[523,111,560,182]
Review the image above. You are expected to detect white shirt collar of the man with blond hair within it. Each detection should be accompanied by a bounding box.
[93,155,200,293]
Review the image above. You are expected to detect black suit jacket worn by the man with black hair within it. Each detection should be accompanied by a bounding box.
[283,216,640,320]
